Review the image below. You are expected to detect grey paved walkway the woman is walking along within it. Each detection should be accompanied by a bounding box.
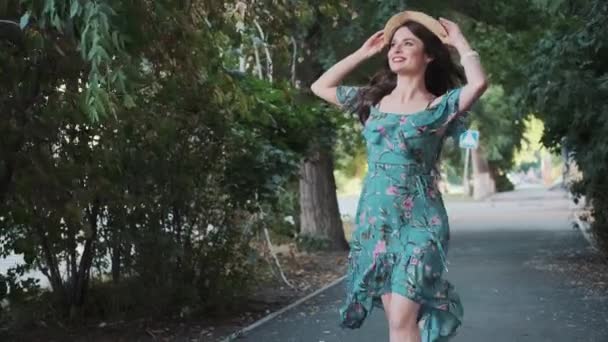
[238,190,608,342]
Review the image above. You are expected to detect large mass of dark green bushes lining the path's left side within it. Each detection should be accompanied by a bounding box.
[0,0,320,326]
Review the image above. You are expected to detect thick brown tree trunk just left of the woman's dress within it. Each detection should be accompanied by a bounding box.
[300,151,348,250]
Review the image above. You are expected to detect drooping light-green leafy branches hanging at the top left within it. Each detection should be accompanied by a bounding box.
[15,0,133,120]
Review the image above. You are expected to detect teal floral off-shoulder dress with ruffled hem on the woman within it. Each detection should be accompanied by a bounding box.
[336,86,466,342]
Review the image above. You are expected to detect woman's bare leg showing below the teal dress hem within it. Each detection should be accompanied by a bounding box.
[388,293,420,342]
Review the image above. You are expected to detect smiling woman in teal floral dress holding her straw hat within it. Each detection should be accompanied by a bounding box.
[311,11,488,342]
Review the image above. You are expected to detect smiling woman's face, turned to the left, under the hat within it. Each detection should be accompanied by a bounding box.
[388,26,431,74]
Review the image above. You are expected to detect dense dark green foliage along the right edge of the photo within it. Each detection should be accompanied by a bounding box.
[524,0,608,250]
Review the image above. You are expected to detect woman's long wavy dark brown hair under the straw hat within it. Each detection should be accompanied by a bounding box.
[347,21,465,124]
